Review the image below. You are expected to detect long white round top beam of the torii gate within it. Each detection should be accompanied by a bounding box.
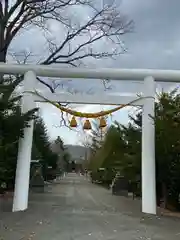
[0,63,180,82]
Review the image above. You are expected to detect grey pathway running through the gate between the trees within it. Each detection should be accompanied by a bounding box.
[0,174,180,240]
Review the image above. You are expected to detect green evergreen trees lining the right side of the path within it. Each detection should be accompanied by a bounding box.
[88,89,180,209]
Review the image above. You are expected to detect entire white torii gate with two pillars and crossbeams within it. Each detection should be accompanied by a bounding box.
[0,63,180,214]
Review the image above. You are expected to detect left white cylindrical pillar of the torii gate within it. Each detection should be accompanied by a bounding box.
[12,71,36,212]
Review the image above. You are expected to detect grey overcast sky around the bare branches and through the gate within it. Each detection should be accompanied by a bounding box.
[12,0,180,144]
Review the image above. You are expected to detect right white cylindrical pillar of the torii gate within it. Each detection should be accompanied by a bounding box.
[142,77,156,214]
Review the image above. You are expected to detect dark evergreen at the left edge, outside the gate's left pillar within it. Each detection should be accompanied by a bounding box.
[0,79,37,187]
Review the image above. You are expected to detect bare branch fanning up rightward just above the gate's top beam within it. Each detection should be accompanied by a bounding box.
[42,3,133,66]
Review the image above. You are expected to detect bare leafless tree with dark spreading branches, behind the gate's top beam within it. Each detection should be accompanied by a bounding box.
[0,0,133,128]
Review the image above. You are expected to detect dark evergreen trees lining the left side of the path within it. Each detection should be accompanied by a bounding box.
[0,78,69,192]
